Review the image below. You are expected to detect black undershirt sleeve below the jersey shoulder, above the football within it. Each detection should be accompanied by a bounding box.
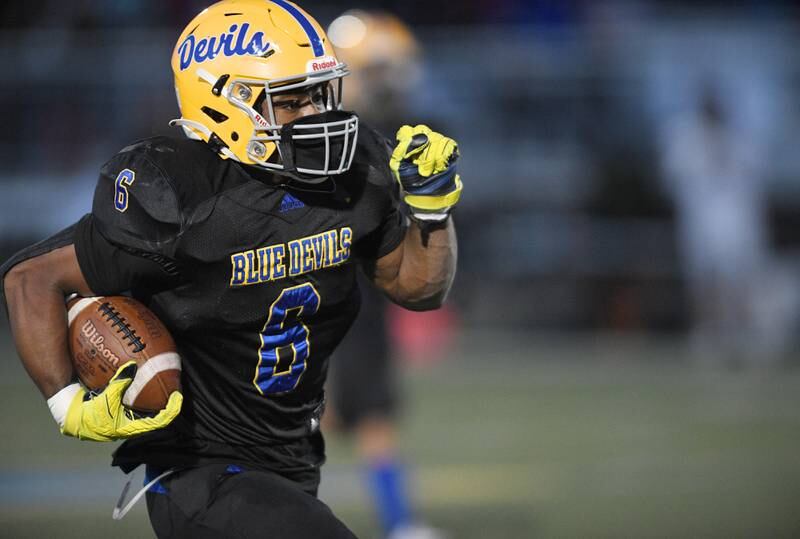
[75,214,181,296]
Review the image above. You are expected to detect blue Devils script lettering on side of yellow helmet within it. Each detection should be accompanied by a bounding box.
[178,23,270,71]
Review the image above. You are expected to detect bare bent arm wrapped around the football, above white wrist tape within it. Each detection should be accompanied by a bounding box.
[3,245,94,398]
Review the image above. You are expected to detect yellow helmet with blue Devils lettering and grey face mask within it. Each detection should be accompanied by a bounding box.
[170,0,358,182]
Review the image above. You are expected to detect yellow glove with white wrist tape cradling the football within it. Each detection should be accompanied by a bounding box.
[48,361,183,442]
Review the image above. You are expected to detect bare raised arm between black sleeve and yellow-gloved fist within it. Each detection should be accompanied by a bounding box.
[368,219,458,311]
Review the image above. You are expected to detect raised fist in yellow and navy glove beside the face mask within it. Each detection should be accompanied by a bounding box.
[389,125,462,222]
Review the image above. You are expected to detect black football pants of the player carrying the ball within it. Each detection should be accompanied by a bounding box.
[147,464,355,539]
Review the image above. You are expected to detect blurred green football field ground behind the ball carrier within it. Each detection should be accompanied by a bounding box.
[0,332,800,539]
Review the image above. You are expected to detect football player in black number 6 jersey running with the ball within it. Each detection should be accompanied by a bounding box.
[0,0,461,539]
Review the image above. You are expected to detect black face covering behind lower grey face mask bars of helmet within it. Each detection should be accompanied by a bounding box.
[277,110,358,183]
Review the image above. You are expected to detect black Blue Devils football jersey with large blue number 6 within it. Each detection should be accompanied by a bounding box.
[75,126,405,488]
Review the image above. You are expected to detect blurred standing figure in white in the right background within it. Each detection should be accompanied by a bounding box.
[662,80,769,361]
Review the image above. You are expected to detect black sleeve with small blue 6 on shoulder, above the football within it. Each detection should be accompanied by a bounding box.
[75,146,182,295]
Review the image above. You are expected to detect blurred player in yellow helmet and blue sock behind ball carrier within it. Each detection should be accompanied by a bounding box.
[324,10,450,539]
